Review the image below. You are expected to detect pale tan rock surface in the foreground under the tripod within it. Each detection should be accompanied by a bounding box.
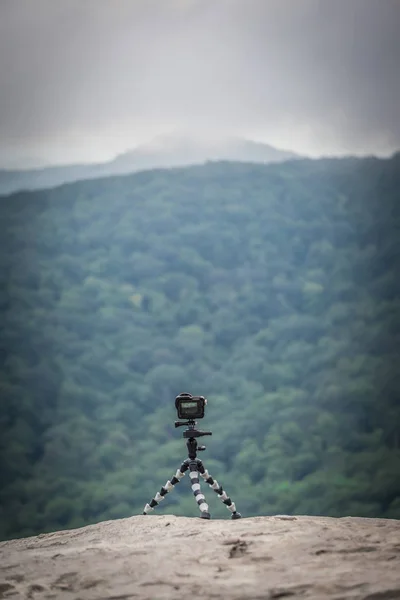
[0,514,400,600]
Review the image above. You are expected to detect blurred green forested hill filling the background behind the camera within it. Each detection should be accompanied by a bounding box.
[0,155,400,538]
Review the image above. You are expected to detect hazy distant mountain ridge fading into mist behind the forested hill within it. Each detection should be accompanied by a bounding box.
[0,134,301,194]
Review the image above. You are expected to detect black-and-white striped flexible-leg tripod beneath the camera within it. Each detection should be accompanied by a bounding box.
[143,419,242,519]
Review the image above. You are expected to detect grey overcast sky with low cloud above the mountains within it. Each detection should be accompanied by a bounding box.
[0,0,400,165]
